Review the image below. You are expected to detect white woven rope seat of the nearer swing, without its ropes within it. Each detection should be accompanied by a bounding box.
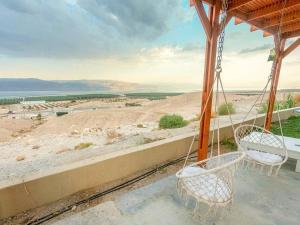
[176,152,245,210]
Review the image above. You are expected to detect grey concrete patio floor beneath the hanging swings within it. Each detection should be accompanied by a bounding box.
[51,160,300,225]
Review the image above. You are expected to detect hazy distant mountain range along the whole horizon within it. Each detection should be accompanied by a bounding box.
[0,78,299,96]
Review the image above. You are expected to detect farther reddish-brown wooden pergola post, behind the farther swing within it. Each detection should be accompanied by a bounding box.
[265,36,285,130]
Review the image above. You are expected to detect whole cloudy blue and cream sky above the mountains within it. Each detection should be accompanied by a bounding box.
[0,0,300,89]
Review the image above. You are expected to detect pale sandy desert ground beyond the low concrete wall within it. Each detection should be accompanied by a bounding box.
[0,92,292,185]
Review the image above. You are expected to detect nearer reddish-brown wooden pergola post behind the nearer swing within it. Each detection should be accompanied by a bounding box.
[195,1,221,160]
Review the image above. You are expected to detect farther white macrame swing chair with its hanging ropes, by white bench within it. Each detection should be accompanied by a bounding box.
[234,1,288,176]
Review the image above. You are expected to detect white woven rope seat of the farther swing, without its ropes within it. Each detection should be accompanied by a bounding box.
[234,125,288,175]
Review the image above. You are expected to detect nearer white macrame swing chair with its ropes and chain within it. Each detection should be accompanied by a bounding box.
[176,0,245,217]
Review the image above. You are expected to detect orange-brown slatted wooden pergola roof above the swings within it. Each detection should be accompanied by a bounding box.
[190,0,300,38]
